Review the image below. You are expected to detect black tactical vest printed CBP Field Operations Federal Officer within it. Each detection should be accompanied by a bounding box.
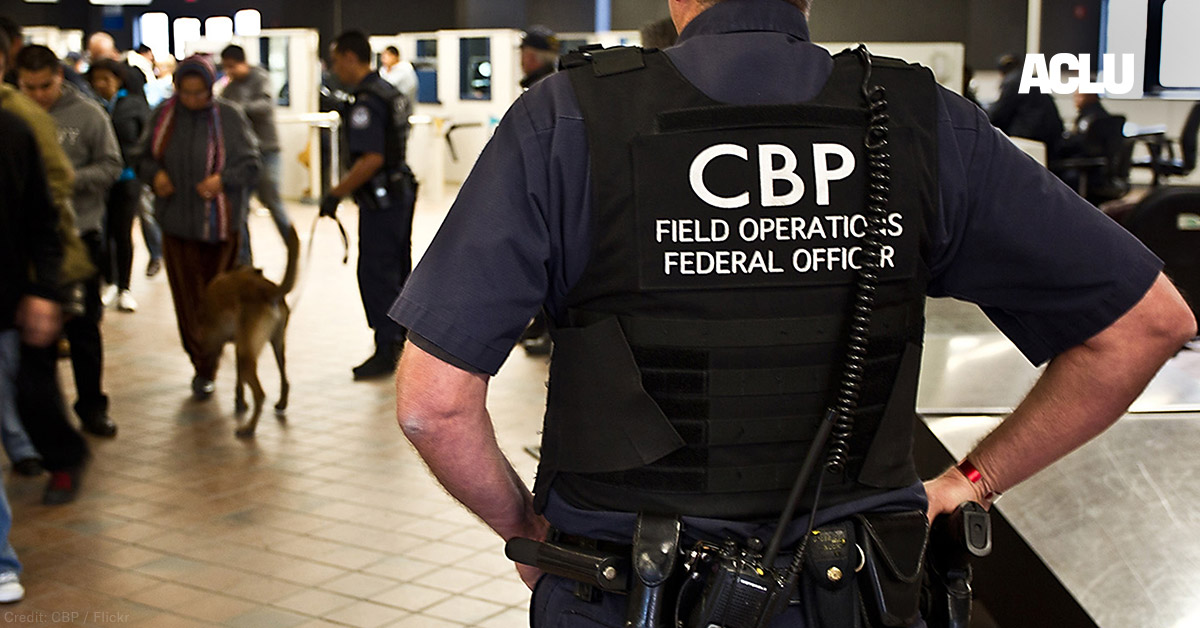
[535,48,938,520]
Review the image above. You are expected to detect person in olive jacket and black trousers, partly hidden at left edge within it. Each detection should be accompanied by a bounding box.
[0,29,96,506]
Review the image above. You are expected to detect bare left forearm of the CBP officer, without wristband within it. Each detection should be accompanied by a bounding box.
[396,343,545,540]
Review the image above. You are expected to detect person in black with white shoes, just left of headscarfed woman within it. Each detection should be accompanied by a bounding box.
[88,59,150,312]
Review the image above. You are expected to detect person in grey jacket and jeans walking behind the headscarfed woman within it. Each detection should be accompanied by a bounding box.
[221,46,292,265]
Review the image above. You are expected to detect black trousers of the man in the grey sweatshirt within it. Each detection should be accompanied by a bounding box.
[62,231,108,418]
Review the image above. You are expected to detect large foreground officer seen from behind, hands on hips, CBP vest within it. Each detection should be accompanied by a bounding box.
[391,0,1195,627]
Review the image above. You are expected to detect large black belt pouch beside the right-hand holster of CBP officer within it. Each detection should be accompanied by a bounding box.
[854,510,929,628]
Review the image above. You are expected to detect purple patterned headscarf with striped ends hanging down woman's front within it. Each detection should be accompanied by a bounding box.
[150,55,230,241]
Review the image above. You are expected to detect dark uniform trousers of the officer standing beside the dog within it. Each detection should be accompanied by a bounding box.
[359,184,415,348]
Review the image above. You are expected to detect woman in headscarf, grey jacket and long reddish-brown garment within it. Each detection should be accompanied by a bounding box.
[137,55,259,400]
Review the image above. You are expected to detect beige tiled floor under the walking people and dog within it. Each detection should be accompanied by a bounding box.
[0,193,546,628]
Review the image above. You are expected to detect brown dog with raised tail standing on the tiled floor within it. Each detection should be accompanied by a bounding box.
[203,227,300,438]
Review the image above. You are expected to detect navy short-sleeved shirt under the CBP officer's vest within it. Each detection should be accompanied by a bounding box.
[391,0,1162,373]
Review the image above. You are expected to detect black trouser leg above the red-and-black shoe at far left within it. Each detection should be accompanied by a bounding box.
[17,343,88,471]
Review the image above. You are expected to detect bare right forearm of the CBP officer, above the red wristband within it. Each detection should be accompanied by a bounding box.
[952,275,1196,494]
